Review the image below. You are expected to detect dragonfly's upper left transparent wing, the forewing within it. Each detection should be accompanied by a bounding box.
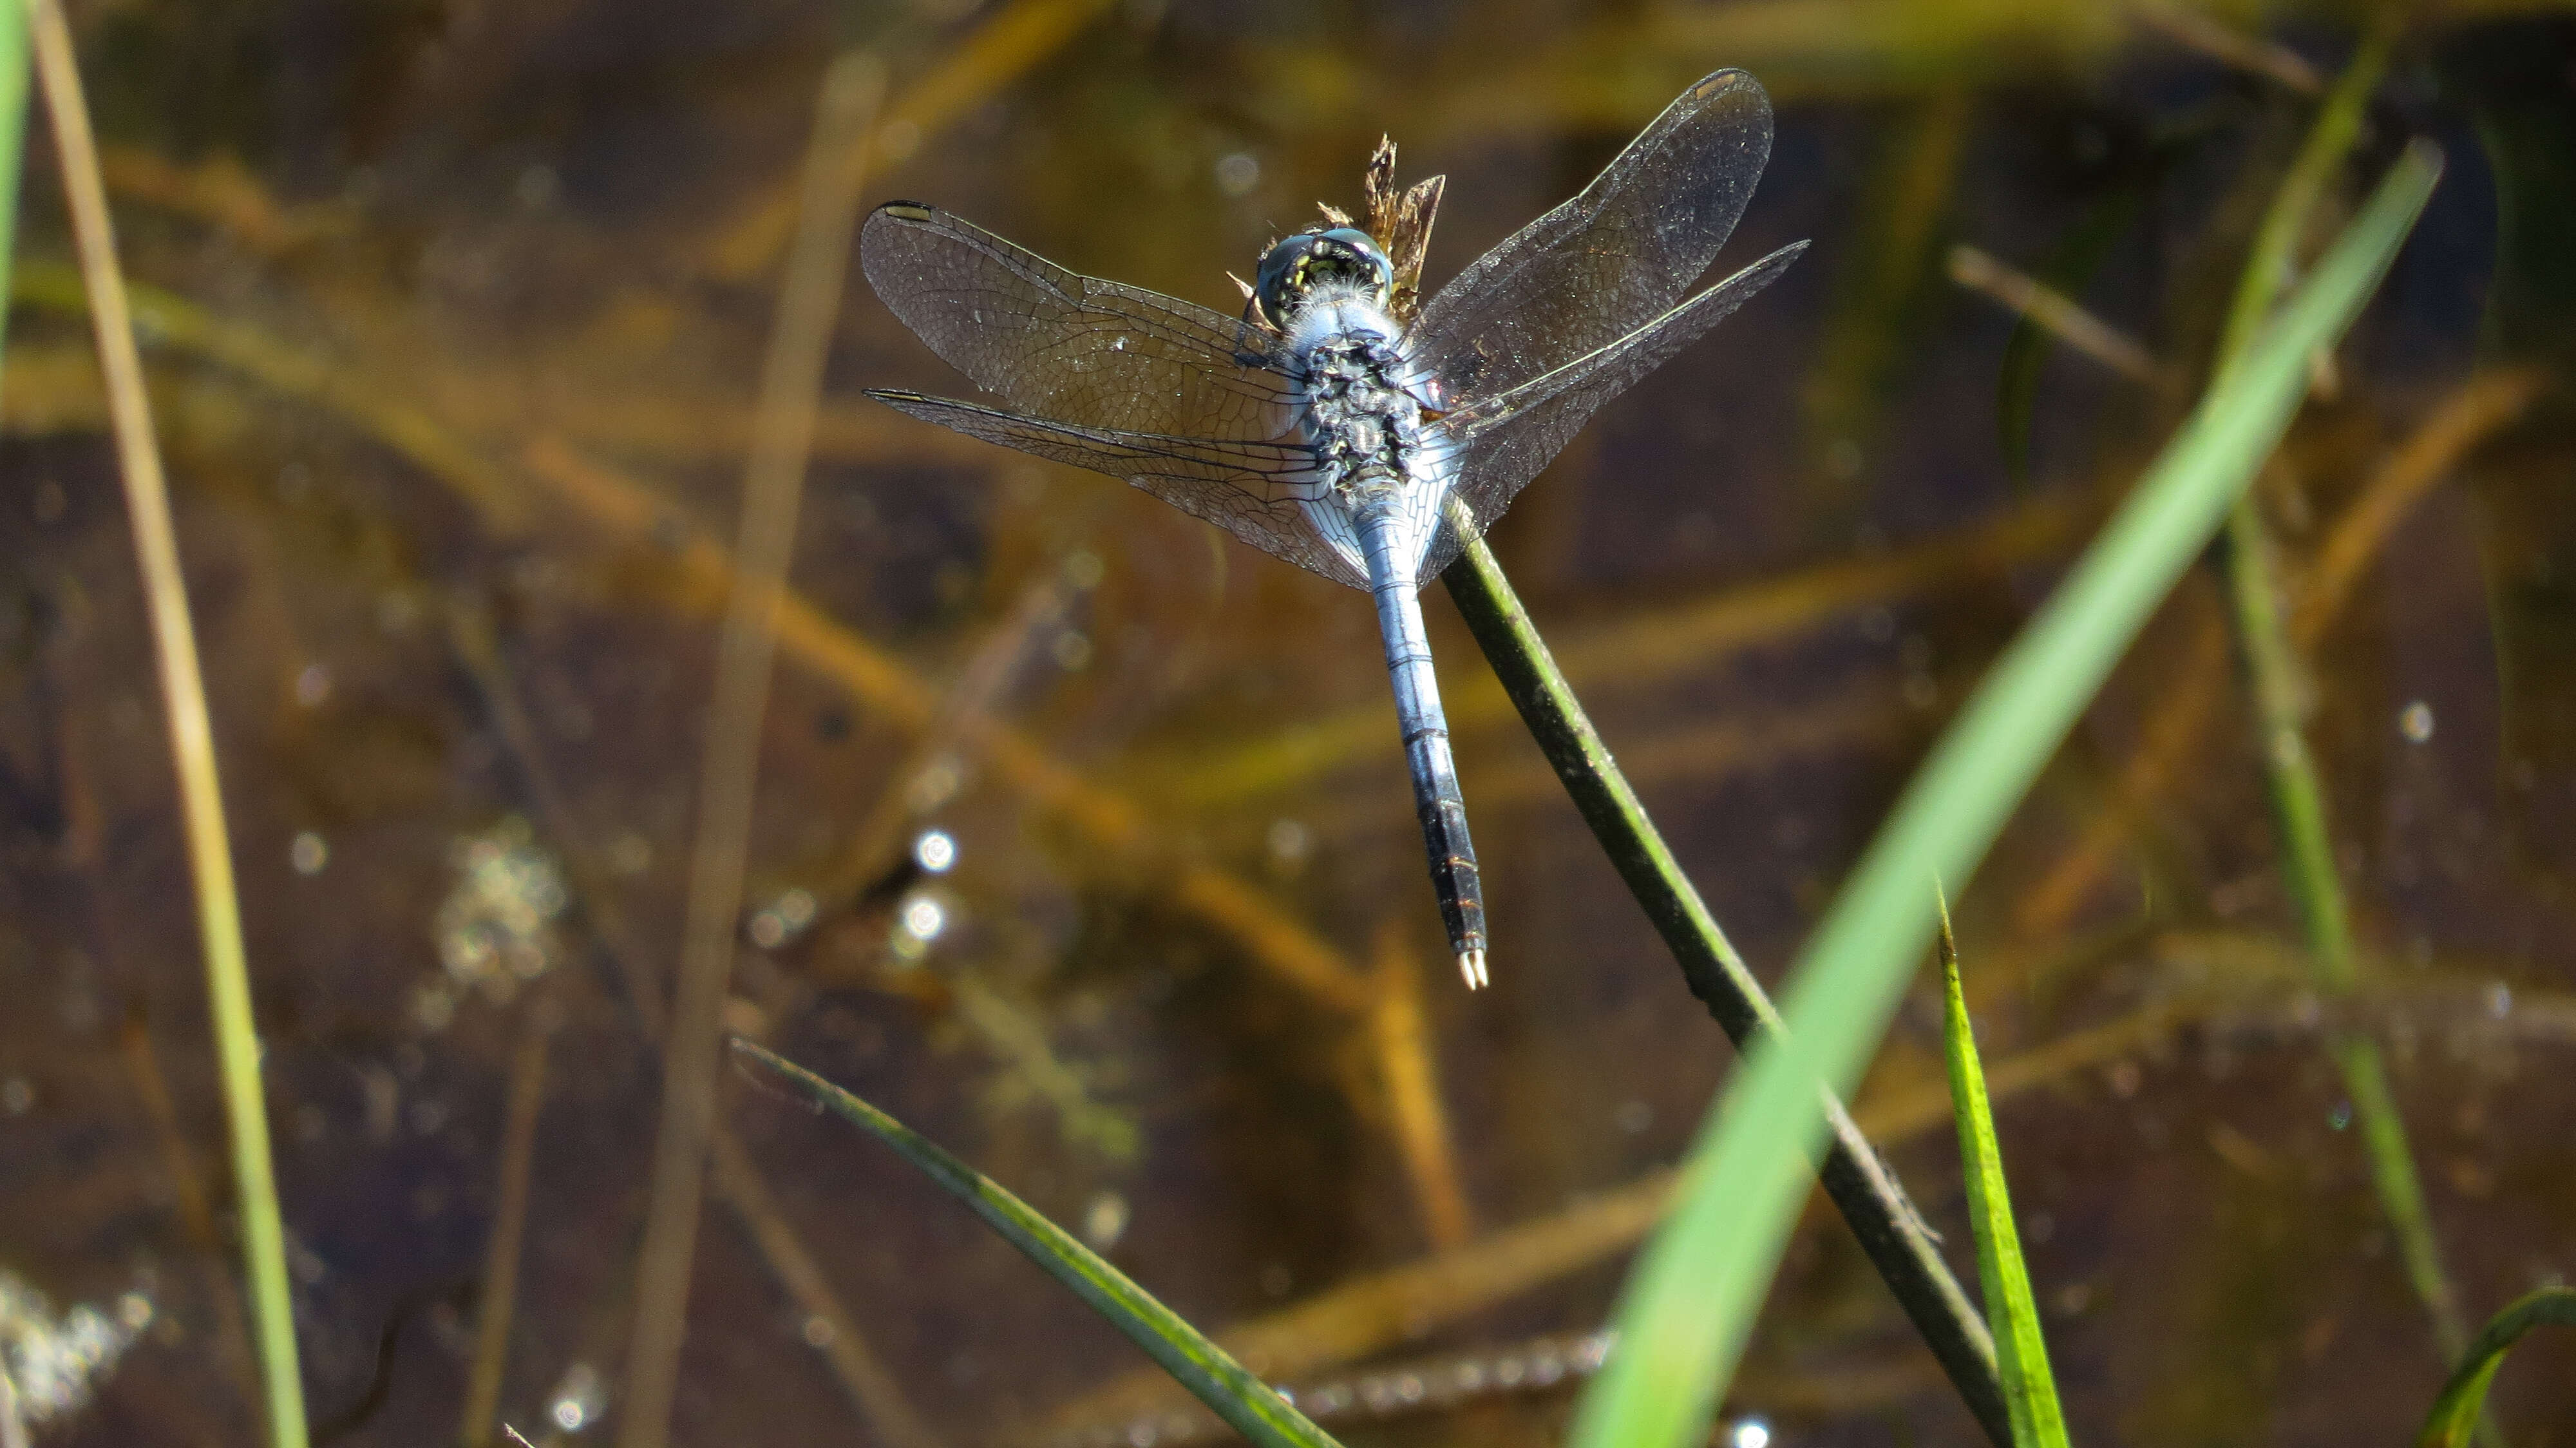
[858,201,1293,441]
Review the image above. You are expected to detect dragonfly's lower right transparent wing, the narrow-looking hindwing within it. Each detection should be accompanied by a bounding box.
[1419,242,1806,585]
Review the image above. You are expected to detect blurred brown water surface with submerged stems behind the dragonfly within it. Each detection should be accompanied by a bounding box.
[0,0,2576,1448]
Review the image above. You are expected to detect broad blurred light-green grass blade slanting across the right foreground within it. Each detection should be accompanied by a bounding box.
[1574,144,2442,1448]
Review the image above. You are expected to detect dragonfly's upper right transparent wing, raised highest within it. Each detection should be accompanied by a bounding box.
[1406,70,1772,402]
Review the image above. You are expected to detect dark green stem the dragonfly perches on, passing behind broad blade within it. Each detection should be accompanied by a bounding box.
[1440,523,2012,1445]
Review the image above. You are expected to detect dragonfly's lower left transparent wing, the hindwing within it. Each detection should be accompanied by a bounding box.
[868,392,1368,587]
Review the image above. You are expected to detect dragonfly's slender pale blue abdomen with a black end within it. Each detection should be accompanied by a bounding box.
[1355,484,1486,989]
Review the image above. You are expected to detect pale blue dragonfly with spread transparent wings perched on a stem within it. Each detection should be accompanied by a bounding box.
[860,70,1806,989]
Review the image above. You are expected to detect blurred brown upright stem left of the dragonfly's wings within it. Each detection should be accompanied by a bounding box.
[618,52,886,1448]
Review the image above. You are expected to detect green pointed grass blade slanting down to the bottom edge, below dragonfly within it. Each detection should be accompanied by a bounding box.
[734,1041,1340,1448]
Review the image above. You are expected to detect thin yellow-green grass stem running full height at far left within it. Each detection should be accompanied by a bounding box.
[26,0,307,1448]
